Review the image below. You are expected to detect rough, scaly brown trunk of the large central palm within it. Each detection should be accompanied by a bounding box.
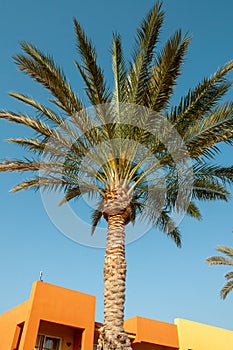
[98,213,131,350]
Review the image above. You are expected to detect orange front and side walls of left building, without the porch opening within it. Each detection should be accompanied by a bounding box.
[0,281,95,350]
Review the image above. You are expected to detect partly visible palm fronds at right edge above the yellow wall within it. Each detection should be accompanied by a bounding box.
[206,246,233,299]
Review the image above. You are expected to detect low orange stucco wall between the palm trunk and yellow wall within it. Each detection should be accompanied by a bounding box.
[125,316,179,350]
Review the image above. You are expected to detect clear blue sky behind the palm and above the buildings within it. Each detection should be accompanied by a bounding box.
[0,0,233,329]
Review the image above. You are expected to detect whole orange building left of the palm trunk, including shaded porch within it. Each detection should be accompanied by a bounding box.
[0,282,95,350]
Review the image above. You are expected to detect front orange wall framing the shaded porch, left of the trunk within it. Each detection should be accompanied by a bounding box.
[19,282,95,350]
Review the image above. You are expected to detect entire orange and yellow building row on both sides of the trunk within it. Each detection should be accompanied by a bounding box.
[0,281,233,350]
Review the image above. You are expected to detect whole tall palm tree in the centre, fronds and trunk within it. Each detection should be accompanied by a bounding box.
[0,2,233,349]
